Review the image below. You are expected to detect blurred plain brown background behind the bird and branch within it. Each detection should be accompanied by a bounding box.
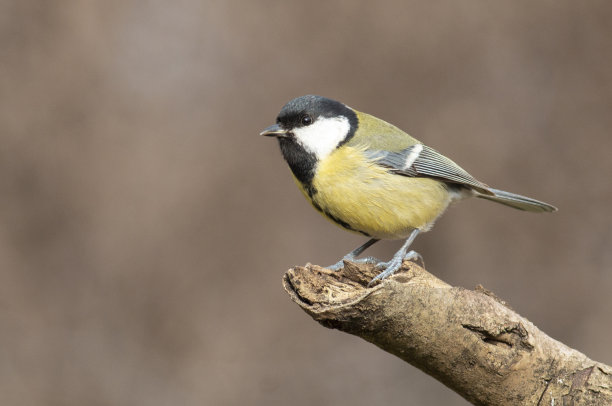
[0,0,612,406]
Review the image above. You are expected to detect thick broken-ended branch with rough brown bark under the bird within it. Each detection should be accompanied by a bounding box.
[283,261,612,406]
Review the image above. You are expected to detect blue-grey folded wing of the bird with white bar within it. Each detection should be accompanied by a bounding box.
[365,144,493,195]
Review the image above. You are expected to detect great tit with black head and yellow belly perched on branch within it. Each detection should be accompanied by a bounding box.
[261,95,557,284]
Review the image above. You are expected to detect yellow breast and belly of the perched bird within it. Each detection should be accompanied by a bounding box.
[300,147,451,239]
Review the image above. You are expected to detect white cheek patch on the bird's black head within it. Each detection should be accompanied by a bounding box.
[293,116,351,159]
